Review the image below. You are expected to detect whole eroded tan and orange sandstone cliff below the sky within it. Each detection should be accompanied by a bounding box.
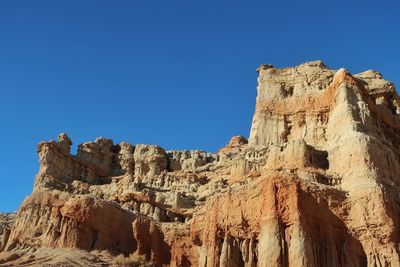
[0,61,400,267]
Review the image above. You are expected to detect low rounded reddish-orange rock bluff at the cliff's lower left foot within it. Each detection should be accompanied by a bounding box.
[5,189,135,253]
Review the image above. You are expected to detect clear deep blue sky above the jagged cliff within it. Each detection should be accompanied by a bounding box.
[0,0,400,214]
